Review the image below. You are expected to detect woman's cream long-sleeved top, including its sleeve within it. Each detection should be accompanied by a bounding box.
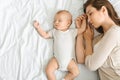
[85,26,120,80]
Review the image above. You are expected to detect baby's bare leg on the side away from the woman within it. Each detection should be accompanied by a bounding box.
[46,57,58,80]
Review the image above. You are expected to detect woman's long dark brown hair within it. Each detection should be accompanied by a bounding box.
[84,0,120,33]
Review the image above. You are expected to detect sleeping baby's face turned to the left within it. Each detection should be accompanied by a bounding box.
[54,13,71,31]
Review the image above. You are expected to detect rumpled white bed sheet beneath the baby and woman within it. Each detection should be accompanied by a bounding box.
[0,0,117,80]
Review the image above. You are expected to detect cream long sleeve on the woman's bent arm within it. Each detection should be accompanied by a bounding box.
[85,29,119,71]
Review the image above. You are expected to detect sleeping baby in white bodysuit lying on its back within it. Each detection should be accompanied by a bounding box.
[33,10,85,80]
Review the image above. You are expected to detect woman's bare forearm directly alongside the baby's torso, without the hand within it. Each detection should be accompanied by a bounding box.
[76,34,85,63]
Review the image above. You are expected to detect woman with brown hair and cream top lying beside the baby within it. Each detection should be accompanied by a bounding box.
[76,0,120,80]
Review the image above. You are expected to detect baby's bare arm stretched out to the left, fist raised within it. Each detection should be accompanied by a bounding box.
[33,21,50,38]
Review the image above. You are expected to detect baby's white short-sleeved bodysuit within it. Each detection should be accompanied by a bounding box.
[49,28,77,63]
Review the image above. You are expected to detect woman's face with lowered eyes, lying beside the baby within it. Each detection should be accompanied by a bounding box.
[86,5,105,28]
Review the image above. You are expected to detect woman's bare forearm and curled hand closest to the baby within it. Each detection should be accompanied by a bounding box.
[75,14,87,63]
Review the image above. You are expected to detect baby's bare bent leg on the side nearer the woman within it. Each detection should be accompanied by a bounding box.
[65,60,79,80]
